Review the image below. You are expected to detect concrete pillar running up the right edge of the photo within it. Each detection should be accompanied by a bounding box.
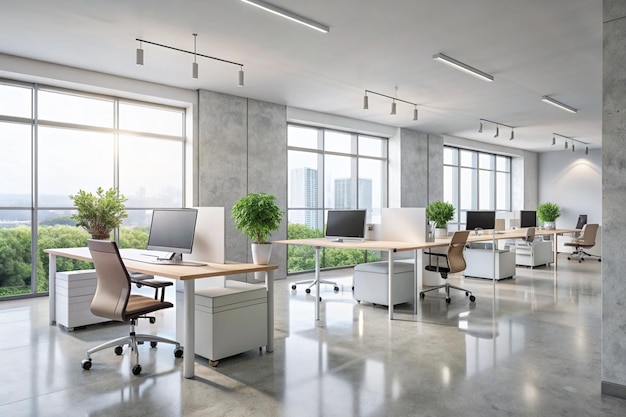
[601,0,626,398]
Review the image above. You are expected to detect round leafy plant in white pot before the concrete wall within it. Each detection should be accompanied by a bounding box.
[231,193,283,265]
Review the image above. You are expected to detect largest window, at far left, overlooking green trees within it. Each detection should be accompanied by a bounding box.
[0,80,185,297]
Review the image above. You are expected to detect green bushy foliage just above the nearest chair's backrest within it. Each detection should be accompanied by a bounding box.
[70,187,128,239]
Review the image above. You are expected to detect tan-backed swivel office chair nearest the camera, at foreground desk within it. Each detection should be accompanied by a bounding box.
[81,239,183,375]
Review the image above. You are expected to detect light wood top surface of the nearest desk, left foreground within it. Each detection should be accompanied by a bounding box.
[44,247,278,281]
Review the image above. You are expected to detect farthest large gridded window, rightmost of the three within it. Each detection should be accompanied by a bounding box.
[443,146,511,231]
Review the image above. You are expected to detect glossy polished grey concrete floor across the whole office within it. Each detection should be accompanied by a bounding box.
[0,256,626,417]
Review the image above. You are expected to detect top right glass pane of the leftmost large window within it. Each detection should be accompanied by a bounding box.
[119,103,185,137]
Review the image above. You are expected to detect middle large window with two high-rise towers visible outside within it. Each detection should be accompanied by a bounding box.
[287,124,387,273]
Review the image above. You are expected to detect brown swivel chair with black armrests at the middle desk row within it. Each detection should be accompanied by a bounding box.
[420,230,476,303]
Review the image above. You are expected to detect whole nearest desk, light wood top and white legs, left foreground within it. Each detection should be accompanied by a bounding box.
[45,247,278,378]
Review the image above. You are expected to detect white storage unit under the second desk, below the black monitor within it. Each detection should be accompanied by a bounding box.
[354,261,415,306]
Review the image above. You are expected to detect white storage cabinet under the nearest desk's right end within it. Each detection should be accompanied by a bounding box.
[195,280,267,361]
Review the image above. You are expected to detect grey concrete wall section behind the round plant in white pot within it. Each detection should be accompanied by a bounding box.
[197,90,287,278]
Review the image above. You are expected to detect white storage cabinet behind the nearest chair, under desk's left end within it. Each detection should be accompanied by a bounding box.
[55,269,109,331]
